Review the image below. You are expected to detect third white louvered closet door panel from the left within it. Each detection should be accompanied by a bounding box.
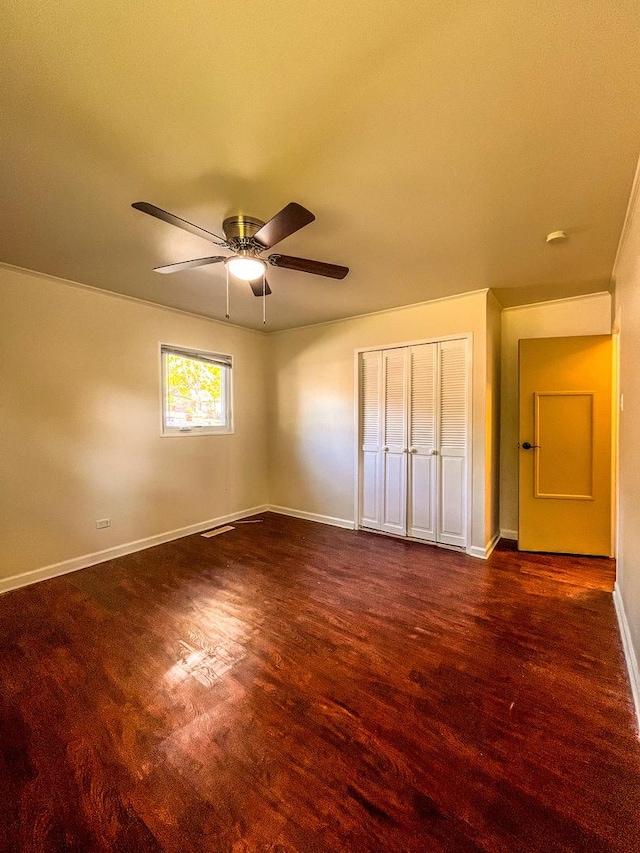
[407,344,438,542]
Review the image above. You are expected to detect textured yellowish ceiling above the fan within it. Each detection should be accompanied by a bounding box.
[0,0,640,331]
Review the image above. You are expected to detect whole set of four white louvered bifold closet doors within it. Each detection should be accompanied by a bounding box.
[359,338,469,548]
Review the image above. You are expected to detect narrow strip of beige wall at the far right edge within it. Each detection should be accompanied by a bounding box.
[614,171,640,680]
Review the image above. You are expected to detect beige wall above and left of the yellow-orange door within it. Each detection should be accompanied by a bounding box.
[500,293,611,538]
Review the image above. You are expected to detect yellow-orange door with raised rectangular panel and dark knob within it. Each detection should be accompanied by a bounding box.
[518,335,612,556]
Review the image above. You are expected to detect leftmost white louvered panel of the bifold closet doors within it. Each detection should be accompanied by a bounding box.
[360,352,382,530]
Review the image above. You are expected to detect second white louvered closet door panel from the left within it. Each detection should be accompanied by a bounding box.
[380,347,409,536]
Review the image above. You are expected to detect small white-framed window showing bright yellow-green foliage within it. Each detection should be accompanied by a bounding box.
[160,344,232,435]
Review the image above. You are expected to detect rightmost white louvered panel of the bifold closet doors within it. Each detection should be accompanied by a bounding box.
[437,340,468,546]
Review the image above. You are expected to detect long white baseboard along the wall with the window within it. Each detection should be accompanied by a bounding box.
[0,506,269,593]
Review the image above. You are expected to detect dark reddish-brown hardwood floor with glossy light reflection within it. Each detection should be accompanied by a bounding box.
[0,514,640,853]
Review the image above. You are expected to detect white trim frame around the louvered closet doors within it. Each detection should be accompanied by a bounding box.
[353,332,473,554]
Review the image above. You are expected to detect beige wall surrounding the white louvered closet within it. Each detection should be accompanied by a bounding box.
[269,291,487,548]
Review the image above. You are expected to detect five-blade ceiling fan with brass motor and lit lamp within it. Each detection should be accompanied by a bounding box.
[131,201,349,296]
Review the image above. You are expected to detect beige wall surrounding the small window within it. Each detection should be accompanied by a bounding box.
[0,267,267,578]
